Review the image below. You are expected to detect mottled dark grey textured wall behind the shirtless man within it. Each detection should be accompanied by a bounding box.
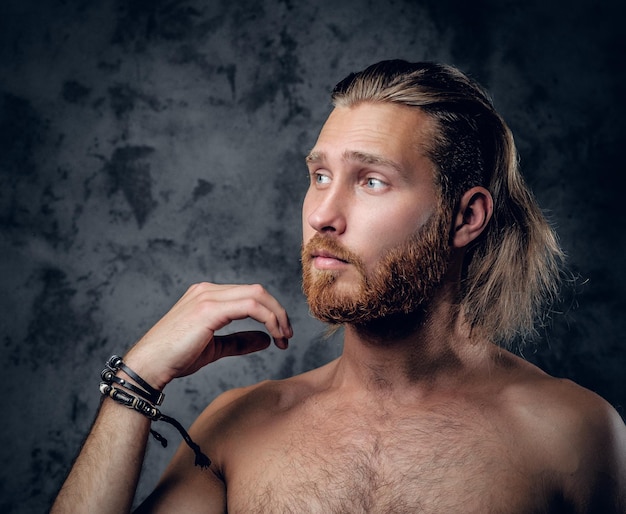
[0,0,626,513]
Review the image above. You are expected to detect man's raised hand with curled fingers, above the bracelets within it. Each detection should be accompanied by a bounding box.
[124,283,293,390]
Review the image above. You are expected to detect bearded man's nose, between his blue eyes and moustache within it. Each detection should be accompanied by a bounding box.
[303,184,346,235]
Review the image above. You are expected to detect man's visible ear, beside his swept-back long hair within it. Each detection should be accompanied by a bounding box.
[451,186,493,248]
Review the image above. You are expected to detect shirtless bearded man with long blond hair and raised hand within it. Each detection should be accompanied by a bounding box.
[53,61,626,513]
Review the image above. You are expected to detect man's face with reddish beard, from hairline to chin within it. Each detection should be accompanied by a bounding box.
[302,103,449,323]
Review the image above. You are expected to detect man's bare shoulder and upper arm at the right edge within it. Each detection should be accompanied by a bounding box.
[494,350,626,513]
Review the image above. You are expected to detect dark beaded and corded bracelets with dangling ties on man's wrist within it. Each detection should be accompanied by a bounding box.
[100,355,211,468]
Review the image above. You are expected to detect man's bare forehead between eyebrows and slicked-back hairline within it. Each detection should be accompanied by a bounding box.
[307,102,434,172]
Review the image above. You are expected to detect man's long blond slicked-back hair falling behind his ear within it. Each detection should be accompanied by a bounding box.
[332,60,563,346]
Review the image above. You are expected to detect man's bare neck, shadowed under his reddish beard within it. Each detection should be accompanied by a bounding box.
[335,294,493,394]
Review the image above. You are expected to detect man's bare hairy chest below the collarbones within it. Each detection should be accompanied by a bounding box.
[226,406,541,514]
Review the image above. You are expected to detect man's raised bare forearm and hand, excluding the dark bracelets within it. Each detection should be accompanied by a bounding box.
[51,283,292,514]
